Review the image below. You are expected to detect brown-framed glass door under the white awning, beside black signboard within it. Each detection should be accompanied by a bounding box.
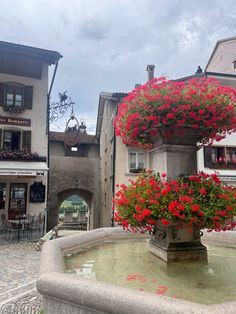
[8,183,27,219]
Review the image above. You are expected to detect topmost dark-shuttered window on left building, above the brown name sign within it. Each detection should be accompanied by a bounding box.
[0,83,33,112]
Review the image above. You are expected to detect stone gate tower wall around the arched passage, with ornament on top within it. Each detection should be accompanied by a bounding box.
[48,115,100,229]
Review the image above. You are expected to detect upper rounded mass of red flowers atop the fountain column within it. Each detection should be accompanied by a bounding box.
[114,77,236,147]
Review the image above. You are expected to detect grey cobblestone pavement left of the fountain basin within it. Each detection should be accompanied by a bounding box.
[0,238,41,314]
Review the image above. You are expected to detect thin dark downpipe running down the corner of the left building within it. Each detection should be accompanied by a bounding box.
[44,60,58,233]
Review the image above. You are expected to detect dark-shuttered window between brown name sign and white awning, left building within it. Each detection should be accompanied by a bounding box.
[0,129,31,153]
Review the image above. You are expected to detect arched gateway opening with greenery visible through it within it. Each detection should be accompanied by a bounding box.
[58,194,90,230]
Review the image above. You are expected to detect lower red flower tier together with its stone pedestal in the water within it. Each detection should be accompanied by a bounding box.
[114,171,236,261]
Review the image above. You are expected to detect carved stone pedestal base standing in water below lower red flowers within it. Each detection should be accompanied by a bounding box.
[149,223,207,263]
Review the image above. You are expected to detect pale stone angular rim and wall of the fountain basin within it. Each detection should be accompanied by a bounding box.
[37,228,236,314]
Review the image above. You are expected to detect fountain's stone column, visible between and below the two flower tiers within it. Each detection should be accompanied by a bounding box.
[149,130,207,263]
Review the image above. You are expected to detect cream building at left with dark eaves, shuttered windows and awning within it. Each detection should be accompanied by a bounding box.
[0,41,62,219]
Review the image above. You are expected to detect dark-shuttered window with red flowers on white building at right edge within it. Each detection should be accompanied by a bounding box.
[204,146,236,169]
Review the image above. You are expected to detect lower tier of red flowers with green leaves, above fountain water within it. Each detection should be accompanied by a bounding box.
[113,171,236,232]
